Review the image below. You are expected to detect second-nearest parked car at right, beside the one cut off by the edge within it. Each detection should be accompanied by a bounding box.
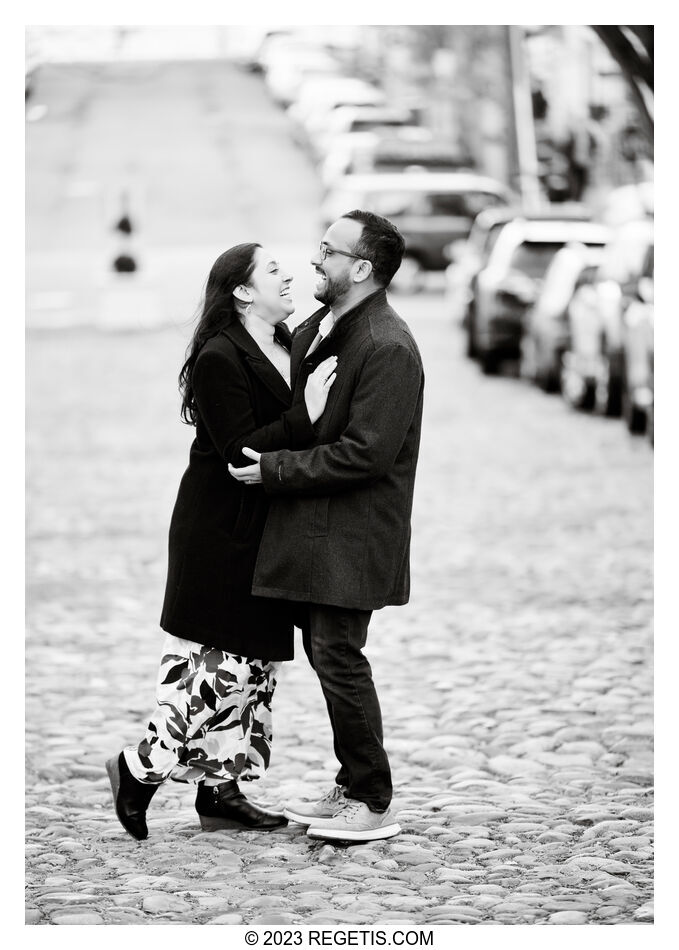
[561,219,653,416]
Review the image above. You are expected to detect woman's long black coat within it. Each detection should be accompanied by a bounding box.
[160,322,314,660]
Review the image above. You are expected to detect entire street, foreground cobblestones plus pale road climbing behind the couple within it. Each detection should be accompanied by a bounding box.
[26,54,653,939]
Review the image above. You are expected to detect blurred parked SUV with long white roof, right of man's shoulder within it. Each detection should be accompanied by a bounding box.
[468,219,608,373]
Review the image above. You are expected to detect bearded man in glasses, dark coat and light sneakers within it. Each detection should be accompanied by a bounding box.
[230,211,424,841]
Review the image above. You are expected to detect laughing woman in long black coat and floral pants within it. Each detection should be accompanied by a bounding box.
[106,244,337,840]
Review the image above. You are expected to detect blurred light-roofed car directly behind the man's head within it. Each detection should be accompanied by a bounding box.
[321,172,511,291]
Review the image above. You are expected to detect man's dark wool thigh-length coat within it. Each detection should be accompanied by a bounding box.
[253,290,424,610]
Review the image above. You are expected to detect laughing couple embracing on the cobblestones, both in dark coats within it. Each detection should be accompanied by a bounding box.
[106,211,424,841]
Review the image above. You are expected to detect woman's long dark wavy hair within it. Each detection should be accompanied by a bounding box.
[179,244,261,426]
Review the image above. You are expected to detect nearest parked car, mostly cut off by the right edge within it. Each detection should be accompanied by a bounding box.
[622,245,654,440]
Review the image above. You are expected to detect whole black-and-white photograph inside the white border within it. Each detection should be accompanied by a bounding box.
[25,4,660,950]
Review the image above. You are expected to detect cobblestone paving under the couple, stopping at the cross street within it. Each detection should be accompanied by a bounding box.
[26,295,653,925]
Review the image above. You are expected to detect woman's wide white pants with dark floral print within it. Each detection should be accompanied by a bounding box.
[125,634,281,783]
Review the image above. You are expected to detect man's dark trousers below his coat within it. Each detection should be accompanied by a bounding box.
[302,604,392,812]
